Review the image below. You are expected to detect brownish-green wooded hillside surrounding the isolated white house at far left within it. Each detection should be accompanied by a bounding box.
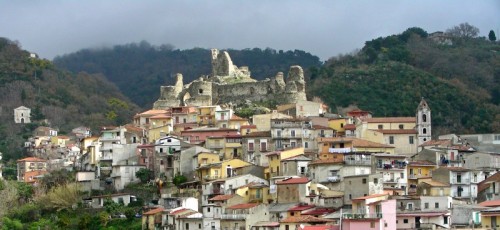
[0,38,138,160]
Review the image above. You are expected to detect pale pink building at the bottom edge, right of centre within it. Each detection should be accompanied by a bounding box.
[341,194,396,230]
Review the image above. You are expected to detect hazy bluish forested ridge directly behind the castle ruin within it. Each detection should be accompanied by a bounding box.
[54,41,322,108]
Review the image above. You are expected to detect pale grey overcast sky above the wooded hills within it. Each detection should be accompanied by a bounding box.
[0,0,500,60]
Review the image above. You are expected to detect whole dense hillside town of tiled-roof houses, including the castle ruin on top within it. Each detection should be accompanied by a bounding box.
[0,49,500,230]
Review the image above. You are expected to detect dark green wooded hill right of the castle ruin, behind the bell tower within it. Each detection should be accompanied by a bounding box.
[308,28,500,135]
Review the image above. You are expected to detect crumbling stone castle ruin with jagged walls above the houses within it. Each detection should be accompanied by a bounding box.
[153,49,306,109]
